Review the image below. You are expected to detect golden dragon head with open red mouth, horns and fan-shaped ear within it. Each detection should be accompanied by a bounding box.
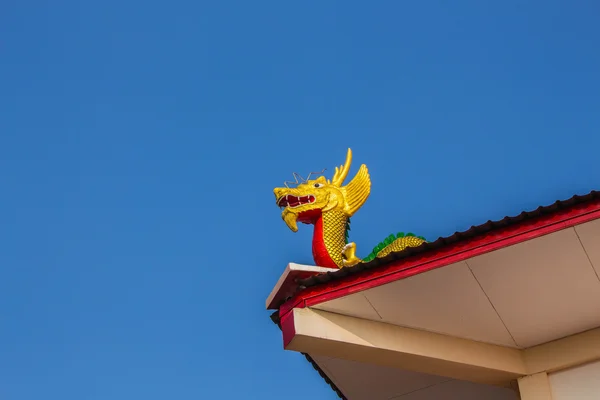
[274,149,371,232]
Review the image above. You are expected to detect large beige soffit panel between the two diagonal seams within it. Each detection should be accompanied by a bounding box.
[467,228,600,348]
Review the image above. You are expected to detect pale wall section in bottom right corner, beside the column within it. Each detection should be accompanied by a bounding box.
[549,361,600,400]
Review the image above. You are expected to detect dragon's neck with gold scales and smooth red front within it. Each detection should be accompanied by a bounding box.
[313,211,349,268]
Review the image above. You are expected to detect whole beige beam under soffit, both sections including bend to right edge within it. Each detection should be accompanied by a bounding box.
[286,308,600,385]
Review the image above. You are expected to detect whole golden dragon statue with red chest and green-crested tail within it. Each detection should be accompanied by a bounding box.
[274,149,425,268]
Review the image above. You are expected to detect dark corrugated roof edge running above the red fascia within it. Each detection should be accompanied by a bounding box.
[271,191,600,399]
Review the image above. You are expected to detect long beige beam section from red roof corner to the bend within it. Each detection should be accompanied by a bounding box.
[286,309,526,384]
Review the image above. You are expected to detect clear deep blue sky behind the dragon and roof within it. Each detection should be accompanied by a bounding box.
[0,0,600,400]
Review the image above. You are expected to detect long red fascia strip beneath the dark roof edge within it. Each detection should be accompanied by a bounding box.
[279,200,600,322]
